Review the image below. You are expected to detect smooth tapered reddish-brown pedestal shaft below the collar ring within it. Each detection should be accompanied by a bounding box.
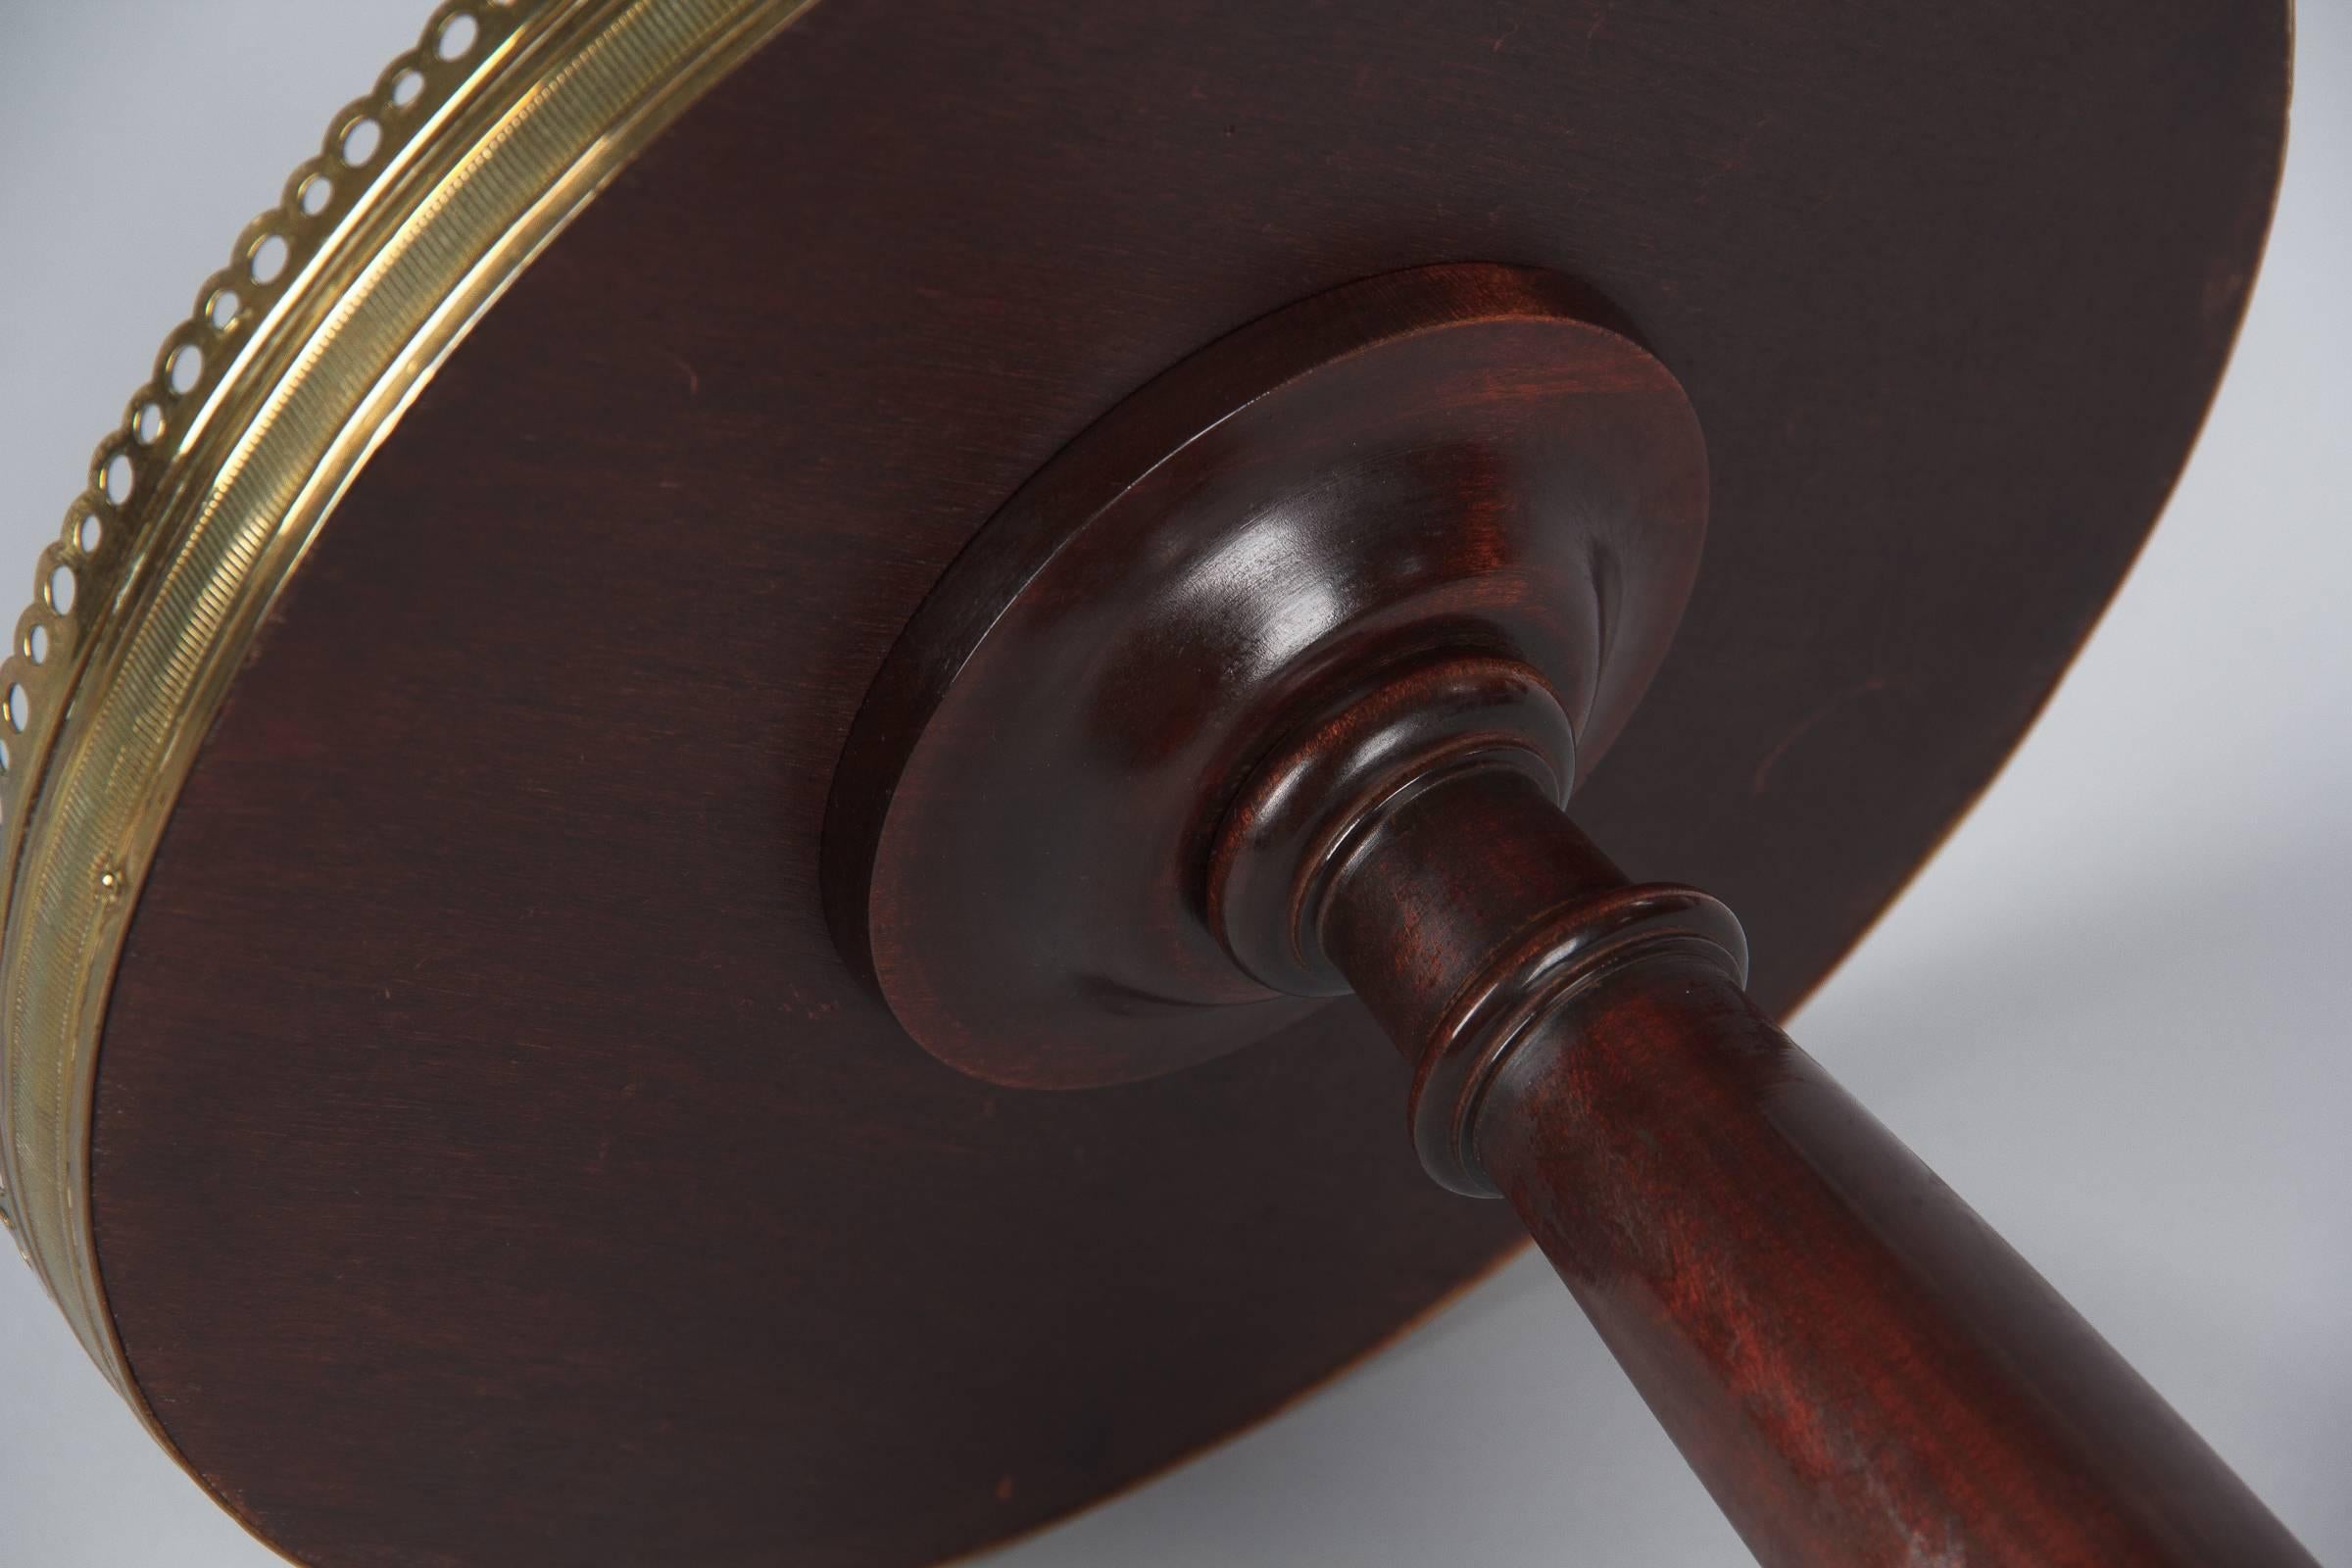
[1477,956,2315,1568]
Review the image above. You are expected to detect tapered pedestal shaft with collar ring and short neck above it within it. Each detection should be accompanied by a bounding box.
[1327,766,2312,1568]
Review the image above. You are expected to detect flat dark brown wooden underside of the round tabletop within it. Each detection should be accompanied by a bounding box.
[92,0,2286,1568]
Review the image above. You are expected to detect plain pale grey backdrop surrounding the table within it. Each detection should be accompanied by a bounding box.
[0,0,2352,1568]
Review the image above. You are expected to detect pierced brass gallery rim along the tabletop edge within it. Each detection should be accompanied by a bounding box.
[0,0,813,1476]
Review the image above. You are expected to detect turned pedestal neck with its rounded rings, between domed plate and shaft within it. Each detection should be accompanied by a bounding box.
[1206,654,1747,1197]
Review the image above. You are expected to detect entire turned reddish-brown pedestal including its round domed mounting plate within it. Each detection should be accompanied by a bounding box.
[825,266,2310,1568]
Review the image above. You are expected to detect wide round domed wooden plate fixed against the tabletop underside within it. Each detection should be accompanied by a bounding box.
[823,264,1707,1089]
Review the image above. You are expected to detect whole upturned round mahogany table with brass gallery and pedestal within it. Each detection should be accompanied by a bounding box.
[0,0,2310,1568]
